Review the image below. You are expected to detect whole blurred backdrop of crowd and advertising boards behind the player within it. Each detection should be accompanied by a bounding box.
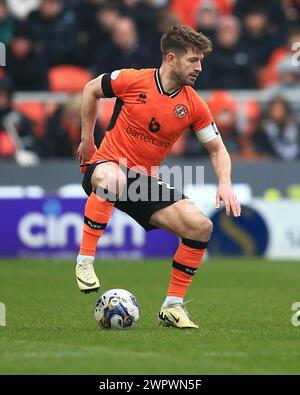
[0,0,300,260]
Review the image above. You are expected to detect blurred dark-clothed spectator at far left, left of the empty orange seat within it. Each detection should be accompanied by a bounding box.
[6,24,48,91]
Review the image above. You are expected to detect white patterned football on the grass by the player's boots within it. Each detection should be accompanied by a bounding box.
[95,288,140,329]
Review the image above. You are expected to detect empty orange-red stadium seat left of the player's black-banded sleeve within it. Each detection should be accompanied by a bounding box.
[48,65,93,93]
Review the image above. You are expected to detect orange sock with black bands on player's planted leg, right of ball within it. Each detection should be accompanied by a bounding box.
[167,239,208,298]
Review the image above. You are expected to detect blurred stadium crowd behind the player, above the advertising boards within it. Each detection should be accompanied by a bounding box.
[0,0,300,164]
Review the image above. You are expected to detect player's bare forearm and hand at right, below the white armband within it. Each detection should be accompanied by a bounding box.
[202,134,241,217]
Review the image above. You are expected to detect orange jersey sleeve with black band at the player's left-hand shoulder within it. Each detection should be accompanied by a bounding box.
[101,69,137,99]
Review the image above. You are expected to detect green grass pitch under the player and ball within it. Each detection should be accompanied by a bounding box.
[0,258,300,375]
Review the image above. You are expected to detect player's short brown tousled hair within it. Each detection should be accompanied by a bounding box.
[160,25,212,57]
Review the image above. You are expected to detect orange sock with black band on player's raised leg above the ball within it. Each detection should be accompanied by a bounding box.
[79,192,114,256]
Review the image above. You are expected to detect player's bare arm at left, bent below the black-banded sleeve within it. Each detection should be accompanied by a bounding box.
[77,74,105,165]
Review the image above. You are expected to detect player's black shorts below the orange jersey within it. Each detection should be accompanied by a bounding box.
[82,161,187,231]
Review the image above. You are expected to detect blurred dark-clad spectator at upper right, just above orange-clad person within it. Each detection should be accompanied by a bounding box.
[241,6,284,67]
